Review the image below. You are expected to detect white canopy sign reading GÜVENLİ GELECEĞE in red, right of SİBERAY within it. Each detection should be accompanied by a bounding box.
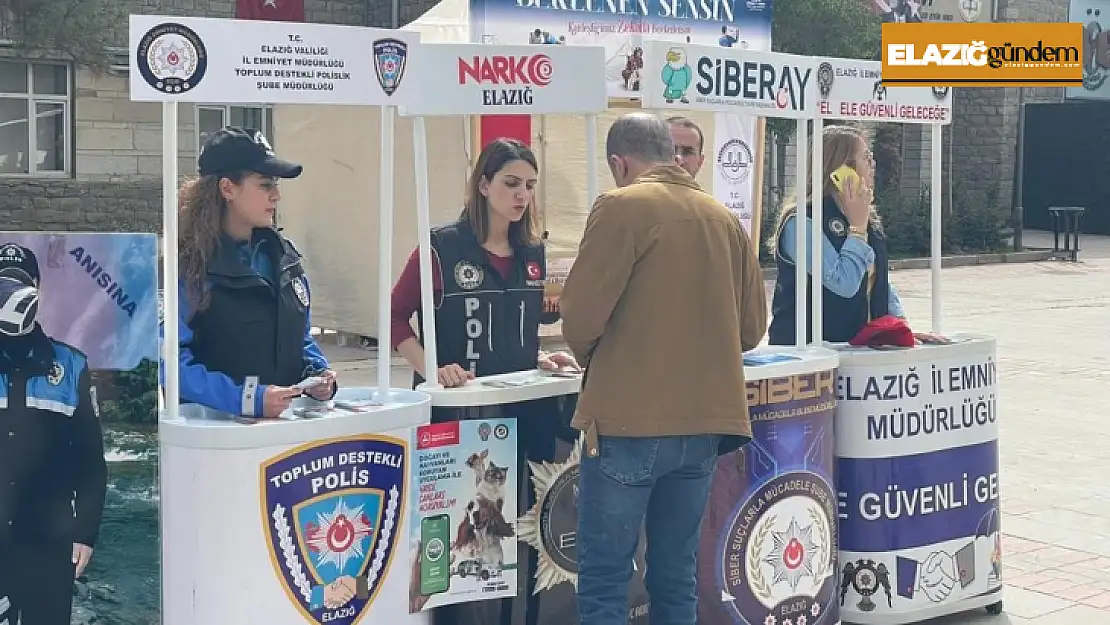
[814,58,952,124]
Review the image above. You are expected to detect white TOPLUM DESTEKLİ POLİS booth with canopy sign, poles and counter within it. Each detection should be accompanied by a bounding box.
[130,16,431,625]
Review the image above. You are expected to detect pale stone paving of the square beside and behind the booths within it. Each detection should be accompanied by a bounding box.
[329,232,1110,625]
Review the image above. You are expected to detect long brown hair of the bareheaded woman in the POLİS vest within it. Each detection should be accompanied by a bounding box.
[458,138,539,246]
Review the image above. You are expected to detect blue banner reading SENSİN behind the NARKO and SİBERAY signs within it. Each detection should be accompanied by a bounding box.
[470,0,773,98]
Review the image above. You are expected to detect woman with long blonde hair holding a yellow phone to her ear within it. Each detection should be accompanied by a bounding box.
[769,125,906,345]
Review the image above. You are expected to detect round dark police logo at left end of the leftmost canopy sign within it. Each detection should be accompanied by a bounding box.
[135,22,209,94]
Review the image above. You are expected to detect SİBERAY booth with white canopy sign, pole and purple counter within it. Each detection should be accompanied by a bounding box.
[642,41,839,625]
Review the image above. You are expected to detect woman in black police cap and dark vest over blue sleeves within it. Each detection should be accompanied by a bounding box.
[166,127,336,417]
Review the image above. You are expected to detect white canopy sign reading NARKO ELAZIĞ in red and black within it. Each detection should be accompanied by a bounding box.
[401,43,608,115]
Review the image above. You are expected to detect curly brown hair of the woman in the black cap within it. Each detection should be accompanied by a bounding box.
[178,173,243,314]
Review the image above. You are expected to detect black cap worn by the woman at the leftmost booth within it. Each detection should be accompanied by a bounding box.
[198,125,304,178]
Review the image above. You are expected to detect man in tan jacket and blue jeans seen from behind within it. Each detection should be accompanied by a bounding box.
[559,112,767,625]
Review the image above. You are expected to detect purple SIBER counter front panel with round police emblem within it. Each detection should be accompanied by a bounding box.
[697,370,840,625]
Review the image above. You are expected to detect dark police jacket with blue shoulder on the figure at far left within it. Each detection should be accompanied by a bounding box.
[0,330,108,546]
